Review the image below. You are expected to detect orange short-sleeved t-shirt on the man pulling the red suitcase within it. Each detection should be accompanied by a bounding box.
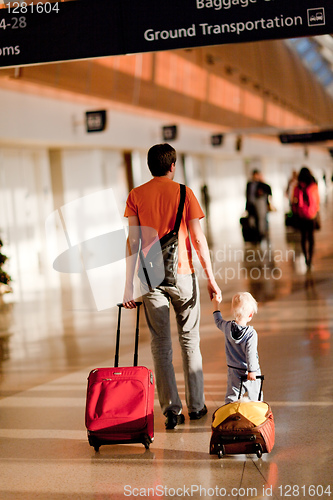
[124,177,204,274]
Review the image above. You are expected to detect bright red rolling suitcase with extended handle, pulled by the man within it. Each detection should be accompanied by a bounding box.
[85,302,155,451]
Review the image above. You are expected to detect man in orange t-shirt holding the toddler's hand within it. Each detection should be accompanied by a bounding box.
[123,144,222,429]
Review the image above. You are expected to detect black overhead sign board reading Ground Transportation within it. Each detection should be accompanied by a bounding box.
[0,0,333,67]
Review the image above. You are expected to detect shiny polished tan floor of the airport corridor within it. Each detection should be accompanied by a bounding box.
[0,192,333,500]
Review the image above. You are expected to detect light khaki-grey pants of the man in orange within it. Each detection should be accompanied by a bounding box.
[141,274,205,414]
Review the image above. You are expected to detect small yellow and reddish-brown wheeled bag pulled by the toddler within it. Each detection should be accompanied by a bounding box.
[210,375,275,458]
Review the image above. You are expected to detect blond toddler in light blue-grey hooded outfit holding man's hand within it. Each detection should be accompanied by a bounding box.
[212,292,261,403]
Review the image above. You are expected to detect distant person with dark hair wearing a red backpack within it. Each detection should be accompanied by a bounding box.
[292,167,320,269]
